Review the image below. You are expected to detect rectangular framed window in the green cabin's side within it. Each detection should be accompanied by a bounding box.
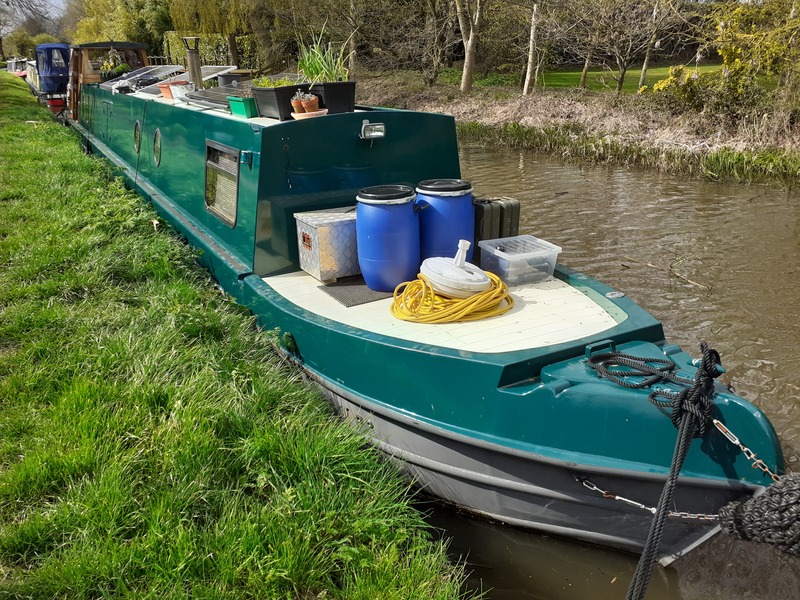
[205,140,239,227]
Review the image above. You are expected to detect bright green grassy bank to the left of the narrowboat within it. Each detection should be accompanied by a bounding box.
[0,73,463,599]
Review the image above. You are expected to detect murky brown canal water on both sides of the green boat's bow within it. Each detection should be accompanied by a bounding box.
[423,148,800,600]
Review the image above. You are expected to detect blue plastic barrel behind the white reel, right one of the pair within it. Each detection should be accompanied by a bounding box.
[417,179,475,260]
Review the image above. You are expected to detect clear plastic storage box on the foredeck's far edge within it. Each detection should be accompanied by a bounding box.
[478,235,561,286]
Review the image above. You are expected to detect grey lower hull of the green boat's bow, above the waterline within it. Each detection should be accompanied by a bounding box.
[314,370,763,565]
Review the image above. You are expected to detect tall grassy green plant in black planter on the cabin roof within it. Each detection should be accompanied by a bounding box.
[297,31,356,113]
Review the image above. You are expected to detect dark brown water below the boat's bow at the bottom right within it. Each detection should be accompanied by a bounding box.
[422,505,800,600]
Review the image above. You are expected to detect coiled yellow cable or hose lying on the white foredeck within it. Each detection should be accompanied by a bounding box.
[391,272,514,323]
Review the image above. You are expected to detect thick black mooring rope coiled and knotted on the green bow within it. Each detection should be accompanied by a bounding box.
[589,342,722,600]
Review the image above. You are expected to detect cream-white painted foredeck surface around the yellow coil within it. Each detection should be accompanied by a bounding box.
[264,271,617,353]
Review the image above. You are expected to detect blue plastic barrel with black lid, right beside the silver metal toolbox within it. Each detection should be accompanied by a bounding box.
[356,185,420,292]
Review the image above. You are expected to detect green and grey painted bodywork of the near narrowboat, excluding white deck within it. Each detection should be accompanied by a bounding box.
[74,79,783,554]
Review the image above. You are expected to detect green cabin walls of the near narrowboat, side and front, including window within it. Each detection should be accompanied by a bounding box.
[79,84,460,284]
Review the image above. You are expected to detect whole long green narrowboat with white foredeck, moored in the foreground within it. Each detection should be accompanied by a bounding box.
[64,54,783,556]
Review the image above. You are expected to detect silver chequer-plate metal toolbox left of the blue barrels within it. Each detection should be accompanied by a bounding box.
[294,206,361,283]
